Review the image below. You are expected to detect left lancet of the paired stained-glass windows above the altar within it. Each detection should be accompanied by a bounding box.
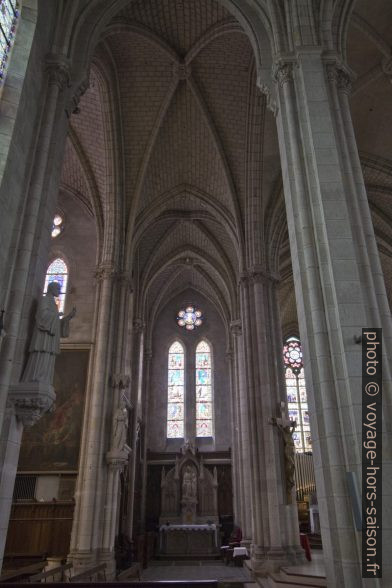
[167,341,185,439]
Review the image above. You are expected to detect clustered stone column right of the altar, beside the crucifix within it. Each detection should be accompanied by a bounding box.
[240,268,303,575]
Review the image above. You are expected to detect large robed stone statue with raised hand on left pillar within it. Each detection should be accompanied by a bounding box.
[22,282,76,385]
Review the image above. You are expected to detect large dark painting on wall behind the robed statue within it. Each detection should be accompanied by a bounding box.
[18,349,89,472]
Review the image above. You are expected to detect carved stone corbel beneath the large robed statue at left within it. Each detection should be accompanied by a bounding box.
[8,382,56,427]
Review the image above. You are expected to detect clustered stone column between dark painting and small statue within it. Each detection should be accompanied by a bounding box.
[69,263,116,570]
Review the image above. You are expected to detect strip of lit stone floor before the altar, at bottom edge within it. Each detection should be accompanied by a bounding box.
[142,562,249,582]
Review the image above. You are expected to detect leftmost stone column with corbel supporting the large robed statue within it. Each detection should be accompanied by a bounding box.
[0,55,69,563]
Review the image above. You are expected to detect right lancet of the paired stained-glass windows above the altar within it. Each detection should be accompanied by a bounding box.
[196,341,213,437]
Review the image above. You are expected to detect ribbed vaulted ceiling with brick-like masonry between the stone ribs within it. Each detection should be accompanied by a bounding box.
[58,0,392,338]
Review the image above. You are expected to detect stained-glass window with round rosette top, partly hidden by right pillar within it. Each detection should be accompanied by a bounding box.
[283,337,312,453]
